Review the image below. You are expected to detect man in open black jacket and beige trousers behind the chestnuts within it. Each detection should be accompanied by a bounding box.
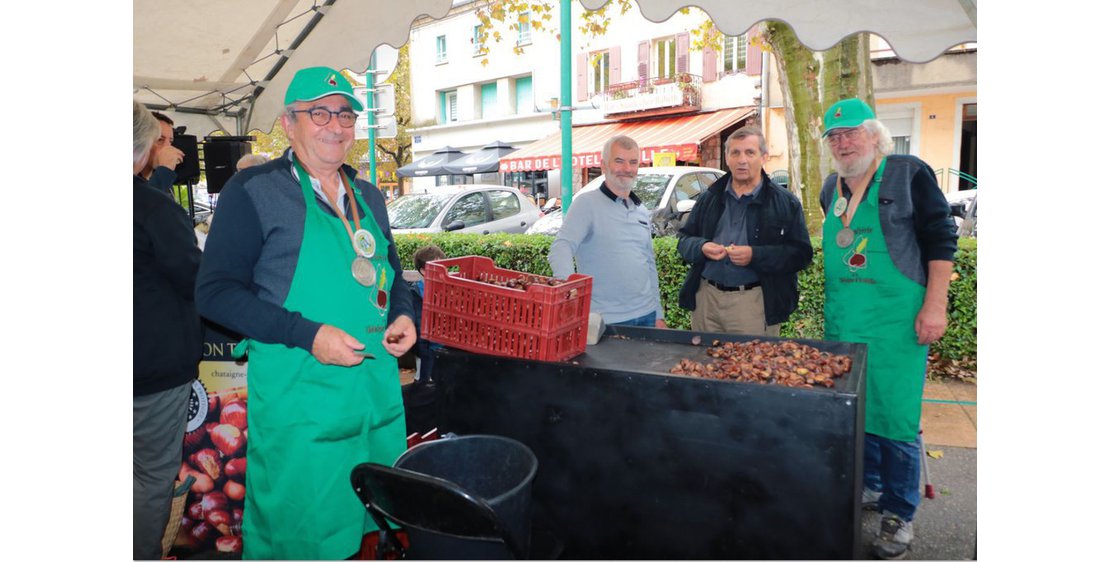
[678,127,814,337]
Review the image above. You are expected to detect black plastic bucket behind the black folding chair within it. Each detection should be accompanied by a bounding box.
[393,435,539,560]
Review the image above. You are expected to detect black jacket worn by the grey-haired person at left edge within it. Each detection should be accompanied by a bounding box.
[132,175,202,397]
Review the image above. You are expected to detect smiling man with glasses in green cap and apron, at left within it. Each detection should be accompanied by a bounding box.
[196,67,416,560]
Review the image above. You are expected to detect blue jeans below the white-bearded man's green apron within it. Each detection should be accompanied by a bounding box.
[864,433,921,521]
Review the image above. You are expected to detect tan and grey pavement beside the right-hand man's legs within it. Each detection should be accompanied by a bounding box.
[862,381,978,560]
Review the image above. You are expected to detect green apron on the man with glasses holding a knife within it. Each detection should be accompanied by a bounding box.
[243,159,405,560]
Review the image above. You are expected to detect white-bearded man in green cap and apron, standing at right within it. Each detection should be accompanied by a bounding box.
[820,98,957,560]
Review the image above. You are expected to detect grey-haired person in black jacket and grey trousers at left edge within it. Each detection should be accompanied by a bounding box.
[132,98,202,560]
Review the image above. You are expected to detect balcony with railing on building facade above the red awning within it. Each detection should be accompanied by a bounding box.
[602,72,702,118]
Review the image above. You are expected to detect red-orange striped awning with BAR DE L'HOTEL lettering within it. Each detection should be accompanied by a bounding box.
[501,107,756,172]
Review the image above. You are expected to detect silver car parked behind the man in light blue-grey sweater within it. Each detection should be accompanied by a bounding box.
[527,165,725,237]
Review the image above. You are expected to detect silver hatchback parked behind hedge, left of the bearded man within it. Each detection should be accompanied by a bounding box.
[385,183,541,234]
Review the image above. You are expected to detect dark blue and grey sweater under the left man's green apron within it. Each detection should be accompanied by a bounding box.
[196,151,414,352]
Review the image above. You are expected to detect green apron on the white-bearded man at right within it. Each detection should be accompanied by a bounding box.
[823,159,929,441]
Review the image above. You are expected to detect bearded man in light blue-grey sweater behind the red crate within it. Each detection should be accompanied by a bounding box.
[547,136,667,328]
